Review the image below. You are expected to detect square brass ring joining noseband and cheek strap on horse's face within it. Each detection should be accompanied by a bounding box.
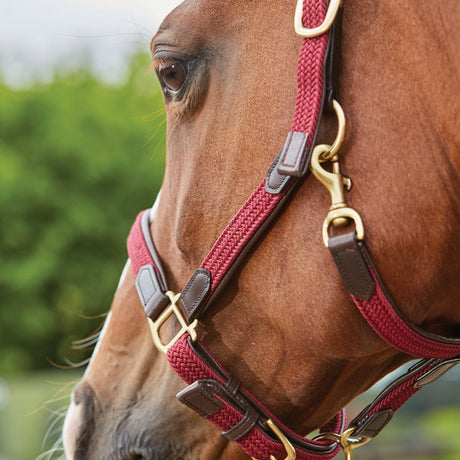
[147,291,198,354]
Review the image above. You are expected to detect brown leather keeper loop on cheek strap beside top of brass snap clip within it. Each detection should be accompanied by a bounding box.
[278,131,308,177]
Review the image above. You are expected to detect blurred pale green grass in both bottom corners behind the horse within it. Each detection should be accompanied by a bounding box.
[0,370,460,460]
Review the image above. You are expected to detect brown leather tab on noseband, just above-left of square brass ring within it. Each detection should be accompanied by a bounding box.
[136,265,169,321]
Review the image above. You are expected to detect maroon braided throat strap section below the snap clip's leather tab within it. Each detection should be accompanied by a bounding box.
[352,270,460,358]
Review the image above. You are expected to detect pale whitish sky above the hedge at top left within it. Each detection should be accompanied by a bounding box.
[0,0,181,87]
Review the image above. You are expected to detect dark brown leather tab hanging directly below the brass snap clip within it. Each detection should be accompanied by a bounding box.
[328,232,375,300]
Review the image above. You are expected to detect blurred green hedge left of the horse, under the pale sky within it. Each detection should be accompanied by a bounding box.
[0,54,165,374]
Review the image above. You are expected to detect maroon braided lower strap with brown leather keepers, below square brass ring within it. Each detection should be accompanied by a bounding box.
[167,335,344,460]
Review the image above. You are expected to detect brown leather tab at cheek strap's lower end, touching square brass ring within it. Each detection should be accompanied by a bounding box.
[178,268,211,322]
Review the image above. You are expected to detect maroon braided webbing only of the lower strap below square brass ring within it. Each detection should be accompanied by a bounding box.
[166,334,343,460]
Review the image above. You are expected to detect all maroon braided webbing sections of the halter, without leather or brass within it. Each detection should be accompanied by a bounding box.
[124,0,460,460]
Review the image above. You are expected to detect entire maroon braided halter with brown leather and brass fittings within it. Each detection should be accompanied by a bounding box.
[128,0,460,460]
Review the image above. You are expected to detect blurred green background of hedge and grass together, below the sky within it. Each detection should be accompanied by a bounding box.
[0,25,460,460]
